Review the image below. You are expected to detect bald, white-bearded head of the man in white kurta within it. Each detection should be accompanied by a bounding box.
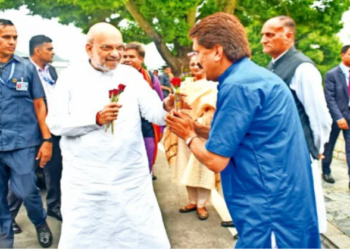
[86,23,125,72]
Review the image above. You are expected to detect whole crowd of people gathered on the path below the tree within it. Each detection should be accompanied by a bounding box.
[0,9,350,249]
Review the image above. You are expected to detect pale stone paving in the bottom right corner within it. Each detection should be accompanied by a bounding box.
[323,158,350,249]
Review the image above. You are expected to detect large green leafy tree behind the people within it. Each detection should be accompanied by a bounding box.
[0,0,350,74]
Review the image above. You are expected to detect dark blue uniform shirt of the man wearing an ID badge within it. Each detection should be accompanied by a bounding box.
[0,55,45,151]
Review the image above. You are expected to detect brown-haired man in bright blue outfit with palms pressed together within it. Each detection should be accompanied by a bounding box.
[167,13,320,248]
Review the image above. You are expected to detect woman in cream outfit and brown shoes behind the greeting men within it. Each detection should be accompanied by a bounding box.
[164,56,217,220]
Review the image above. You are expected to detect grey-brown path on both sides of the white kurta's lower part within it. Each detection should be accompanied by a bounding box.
[14,147,234,249]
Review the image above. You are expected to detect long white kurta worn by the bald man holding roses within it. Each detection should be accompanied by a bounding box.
[47,62,170,248]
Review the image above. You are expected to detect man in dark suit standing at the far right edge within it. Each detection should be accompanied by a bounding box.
[322,45,350,188]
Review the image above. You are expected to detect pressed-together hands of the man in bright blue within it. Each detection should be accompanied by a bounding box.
[165,110,197,140]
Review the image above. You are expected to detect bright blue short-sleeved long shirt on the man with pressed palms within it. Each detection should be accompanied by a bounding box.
[206,58,320,248]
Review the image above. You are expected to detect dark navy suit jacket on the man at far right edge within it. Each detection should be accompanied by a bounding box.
[325,66,350,122]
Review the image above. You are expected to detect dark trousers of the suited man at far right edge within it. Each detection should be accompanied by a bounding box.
[322,120,350,177]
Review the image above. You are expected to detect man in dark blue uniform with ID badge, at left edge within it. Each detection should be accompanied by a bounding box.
[0,19,52,248]
